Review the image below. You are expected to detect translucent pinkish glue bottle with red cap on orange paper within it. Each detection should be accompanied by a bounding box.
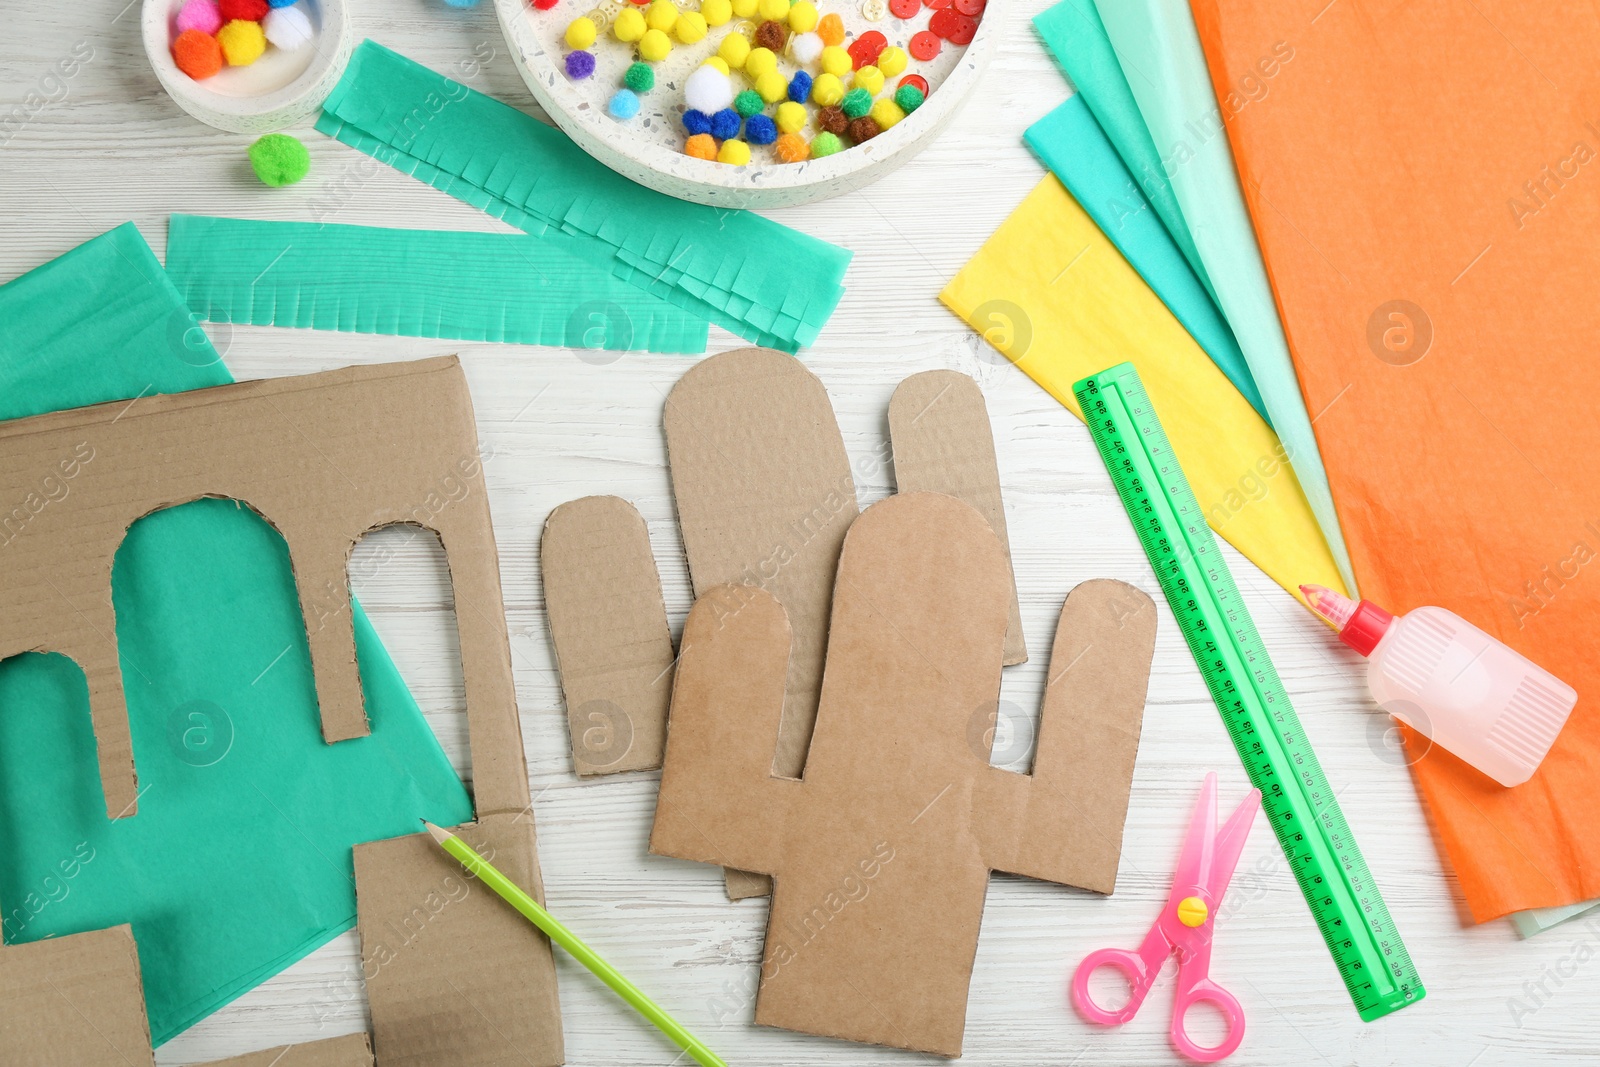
[1301,585,1578,785]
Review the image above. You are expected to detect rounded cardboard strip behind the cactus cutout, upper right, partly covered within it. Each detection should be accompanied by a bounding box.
[890,371,1027,667]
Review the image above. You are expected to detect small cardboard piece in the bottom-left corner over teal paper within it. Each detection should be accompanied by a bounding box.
[0,926,155,1067]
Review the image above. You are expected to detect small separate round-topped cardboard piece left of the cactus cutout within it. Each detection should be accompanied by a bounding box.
[539,496,672,774]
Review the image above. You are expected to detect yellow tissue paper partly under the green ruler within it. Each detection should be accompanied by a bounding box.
[939,174,1344,597]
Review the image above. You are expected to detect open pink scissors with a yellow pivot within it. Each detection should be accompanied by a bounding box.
[1072,773,1261,1064]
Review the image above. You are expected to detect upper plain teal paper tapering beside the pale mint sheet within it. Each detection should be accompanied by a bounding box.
[1034,0,1216,302]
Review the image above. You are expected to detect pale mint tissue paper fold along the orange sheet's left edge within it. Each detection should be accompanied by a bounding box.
[1096,0,1355,595]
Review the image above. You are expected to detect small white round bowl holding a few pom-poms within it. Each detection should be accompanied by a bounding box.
[141,0,352,133]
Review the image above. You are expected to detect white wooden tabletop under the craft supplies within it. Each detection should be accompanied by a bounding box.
[0,0,1600,1067]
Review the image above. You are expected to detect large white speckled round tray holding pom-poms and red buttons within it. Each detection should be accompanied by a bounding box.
[494,0,1005,208]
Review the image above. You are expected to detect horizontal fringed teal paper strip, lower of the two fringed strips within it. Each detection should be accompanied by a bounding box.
[166,214,709,352]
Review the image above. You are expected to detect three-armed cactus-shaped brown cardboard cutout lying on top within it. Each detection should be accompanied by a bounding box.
[650,493,1155,1056]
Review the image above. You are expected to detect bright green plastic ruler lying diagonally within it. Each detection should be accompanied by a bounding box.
[1072,363,1424,1022]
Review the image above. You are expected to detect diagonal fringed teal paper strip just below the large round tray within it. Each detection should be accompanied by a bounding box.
[317,40,850,352]
